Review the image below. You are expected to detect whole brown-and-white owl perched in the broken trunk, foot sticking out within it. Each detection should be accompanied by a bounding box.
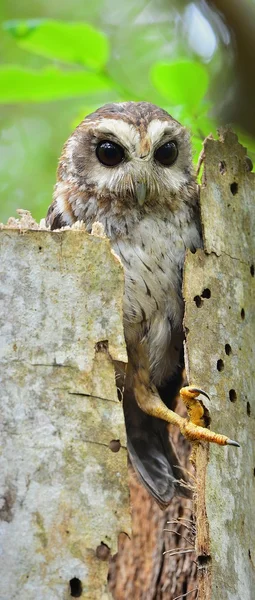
[46,102,239,507]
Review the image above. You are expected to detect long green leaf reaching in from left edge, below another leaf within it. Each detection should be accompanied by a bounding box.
[0,65,113,104]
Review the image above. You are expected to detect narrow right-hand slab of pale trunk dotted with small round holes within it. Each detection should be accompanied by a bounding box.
[184,131,255,600]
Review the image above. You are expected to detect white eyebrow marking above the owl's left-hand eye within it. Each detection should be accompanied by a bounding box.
[96,119,140,149]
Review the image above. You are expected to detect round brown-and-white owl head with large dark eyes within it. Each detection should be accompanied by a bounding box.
[48,102,195,233]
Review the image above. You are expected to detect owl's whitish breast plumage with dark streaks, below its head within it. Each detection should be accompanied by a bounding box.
[113,217,201,385]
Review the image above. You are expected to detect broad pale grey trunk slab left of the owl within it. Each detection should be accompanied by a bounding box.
[0,223,130,600]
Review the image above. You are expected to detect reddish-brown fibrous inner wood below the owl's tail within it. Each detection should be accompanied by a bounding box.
[110,403,197,600]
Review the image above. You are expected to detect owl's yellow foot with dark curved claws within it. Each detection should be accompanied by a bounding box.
[180,385,240,447]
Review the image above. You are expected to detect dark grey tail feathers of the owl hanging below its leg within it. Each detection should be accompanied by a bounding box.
[123,391,192,509]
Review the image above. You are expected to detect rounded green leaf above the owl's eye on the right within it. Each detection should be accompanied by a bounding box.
[151,60,209,113]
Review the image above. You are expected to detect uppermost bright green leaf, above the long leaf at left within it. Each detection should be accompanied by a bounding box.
[3,19,109,69]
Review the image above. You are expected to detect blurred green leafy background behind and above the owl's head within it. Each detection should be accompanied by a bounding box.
[0,0,254,220]
